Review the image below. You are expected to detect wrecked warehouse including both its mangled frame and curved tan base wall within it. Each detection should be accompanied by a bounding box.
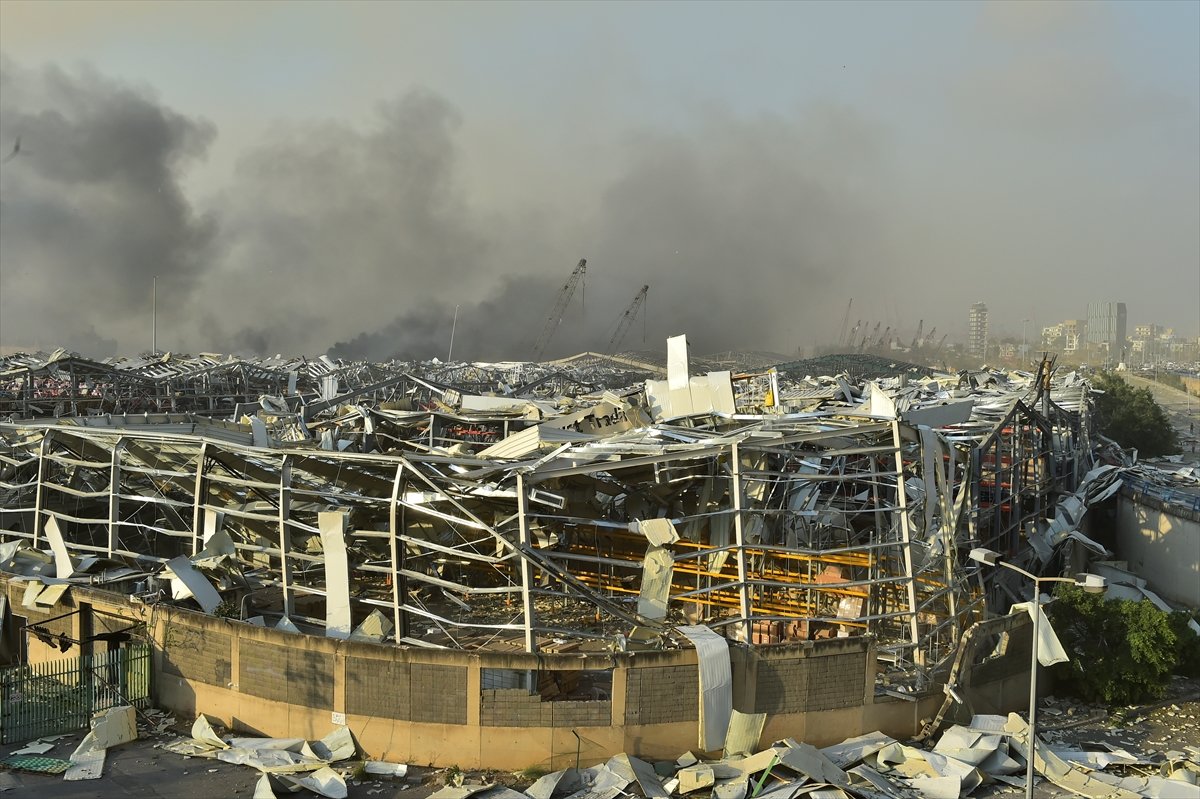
[0,337,1142,768]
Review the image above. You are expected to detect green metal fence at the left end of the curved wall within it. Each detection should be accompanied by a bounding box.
[0,643,150,744]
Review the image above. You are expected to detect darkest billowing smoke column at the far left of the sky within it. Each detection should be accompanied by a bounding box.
[0,58,216,355]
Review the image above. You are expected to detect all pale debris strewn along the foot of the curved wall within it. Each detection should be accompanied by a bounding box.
[0,690,1200,799]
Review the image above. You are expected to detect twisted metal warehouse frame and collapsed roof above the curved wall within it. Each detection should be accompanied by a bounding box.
[0,338,1108,671]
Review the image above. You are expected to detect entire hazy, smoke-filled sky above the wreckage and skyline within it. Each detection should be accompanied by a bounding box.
[0,0,1200,358]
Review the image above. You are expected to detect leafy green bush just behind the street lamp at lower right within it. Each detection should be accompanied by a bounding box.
[1046,585,1195,704]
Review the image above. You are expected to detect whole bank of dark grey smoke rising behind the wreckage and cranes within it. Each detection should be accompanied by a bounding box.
[0,61,882,360]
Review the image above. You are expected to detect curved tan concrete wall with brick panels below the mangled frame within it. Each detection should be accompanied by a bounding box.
[0,578,1027,769]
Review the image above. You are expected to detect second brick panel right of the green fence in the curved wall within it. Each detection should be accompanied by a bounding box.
[238,638,334,710]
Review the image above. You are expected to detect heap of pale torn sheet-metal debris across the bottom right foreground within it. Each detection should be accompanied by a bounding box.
[412,714,1200,799]
